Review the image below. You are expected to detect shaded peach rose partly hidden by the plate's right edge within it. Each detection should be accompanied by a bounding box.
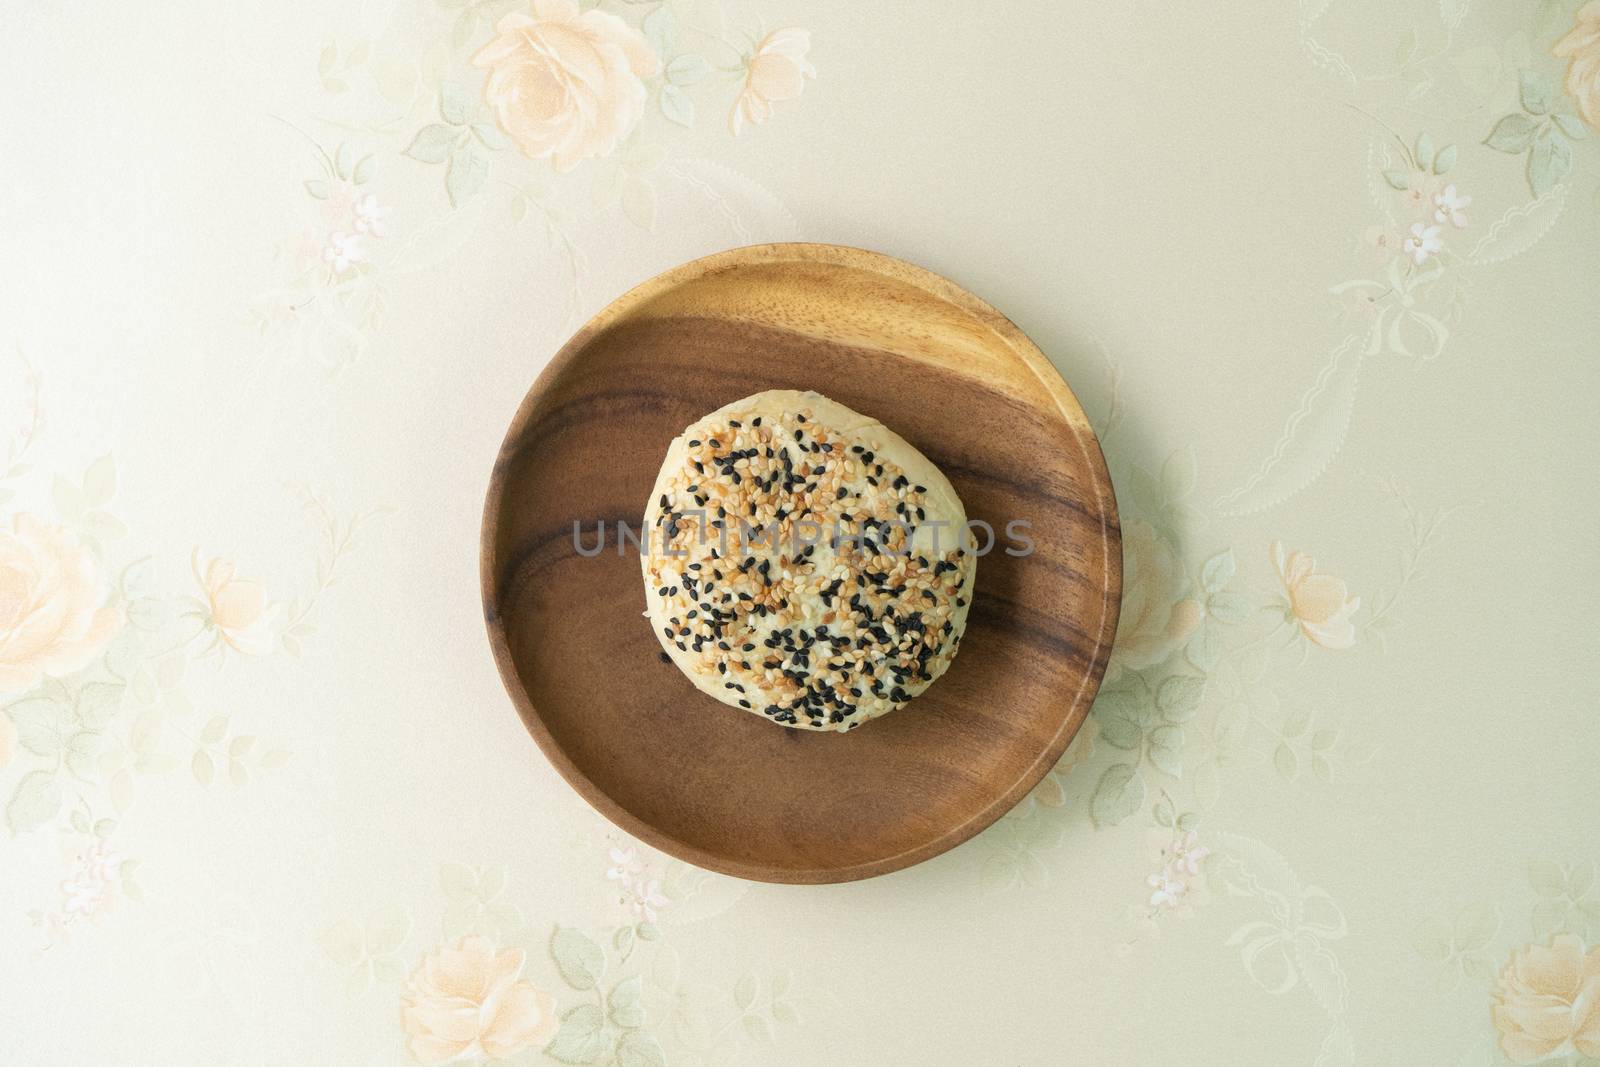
[1112,518,1202,670]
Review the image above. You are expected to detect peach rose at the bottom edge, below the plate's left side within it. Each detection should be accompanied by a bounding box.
[400,936,555,1064]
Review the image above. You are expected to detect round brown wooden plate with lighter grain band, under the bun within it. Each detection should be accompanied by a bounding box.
[482,245,1122,881]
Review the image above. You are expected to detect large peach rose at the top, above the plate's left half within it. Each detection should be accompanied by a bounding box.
[472,0,661,171]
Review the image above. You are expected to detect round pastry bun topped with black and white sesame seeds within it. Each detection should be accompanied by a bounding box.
[640,390,978,731]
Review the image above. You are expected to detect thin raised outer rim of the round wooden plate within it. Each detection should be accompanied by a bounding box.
[478,242,1123,885]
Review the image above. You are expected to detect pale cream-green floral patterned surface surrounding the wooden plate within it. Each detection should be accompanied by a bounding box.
[0,0,1600,1067]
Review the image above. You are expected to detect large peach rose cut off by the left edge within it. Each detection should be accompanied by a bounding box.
[0,515,122,693]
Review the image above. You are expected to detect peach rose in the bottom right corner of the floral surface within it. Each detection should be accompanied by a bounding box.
[1491,934,1600,1064]
